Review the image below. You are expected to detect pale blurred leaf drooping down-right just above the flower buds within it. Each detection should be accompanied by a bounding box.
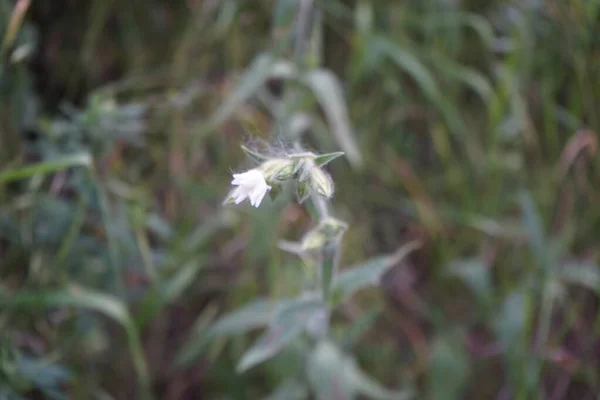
[303,69,363,167]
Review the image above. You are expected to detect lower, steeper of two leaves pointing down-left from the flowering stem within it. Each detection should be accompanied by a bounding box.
[237,299,324,372]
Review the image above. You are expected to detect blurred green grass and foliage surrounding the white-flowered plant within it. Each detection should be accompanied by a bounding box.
[0,0,600,400]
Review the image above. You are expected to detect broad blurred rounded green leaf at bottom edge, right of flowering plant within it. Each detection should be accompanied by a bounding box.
[428,336,469,400]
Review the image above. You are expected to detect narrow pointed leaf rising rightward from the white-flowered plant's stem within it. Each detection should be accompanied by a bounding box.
[332,241,421,301]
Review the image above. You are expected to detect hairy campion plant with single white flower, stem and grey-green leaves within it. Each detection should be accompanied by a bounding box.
[206,146,420,400]
